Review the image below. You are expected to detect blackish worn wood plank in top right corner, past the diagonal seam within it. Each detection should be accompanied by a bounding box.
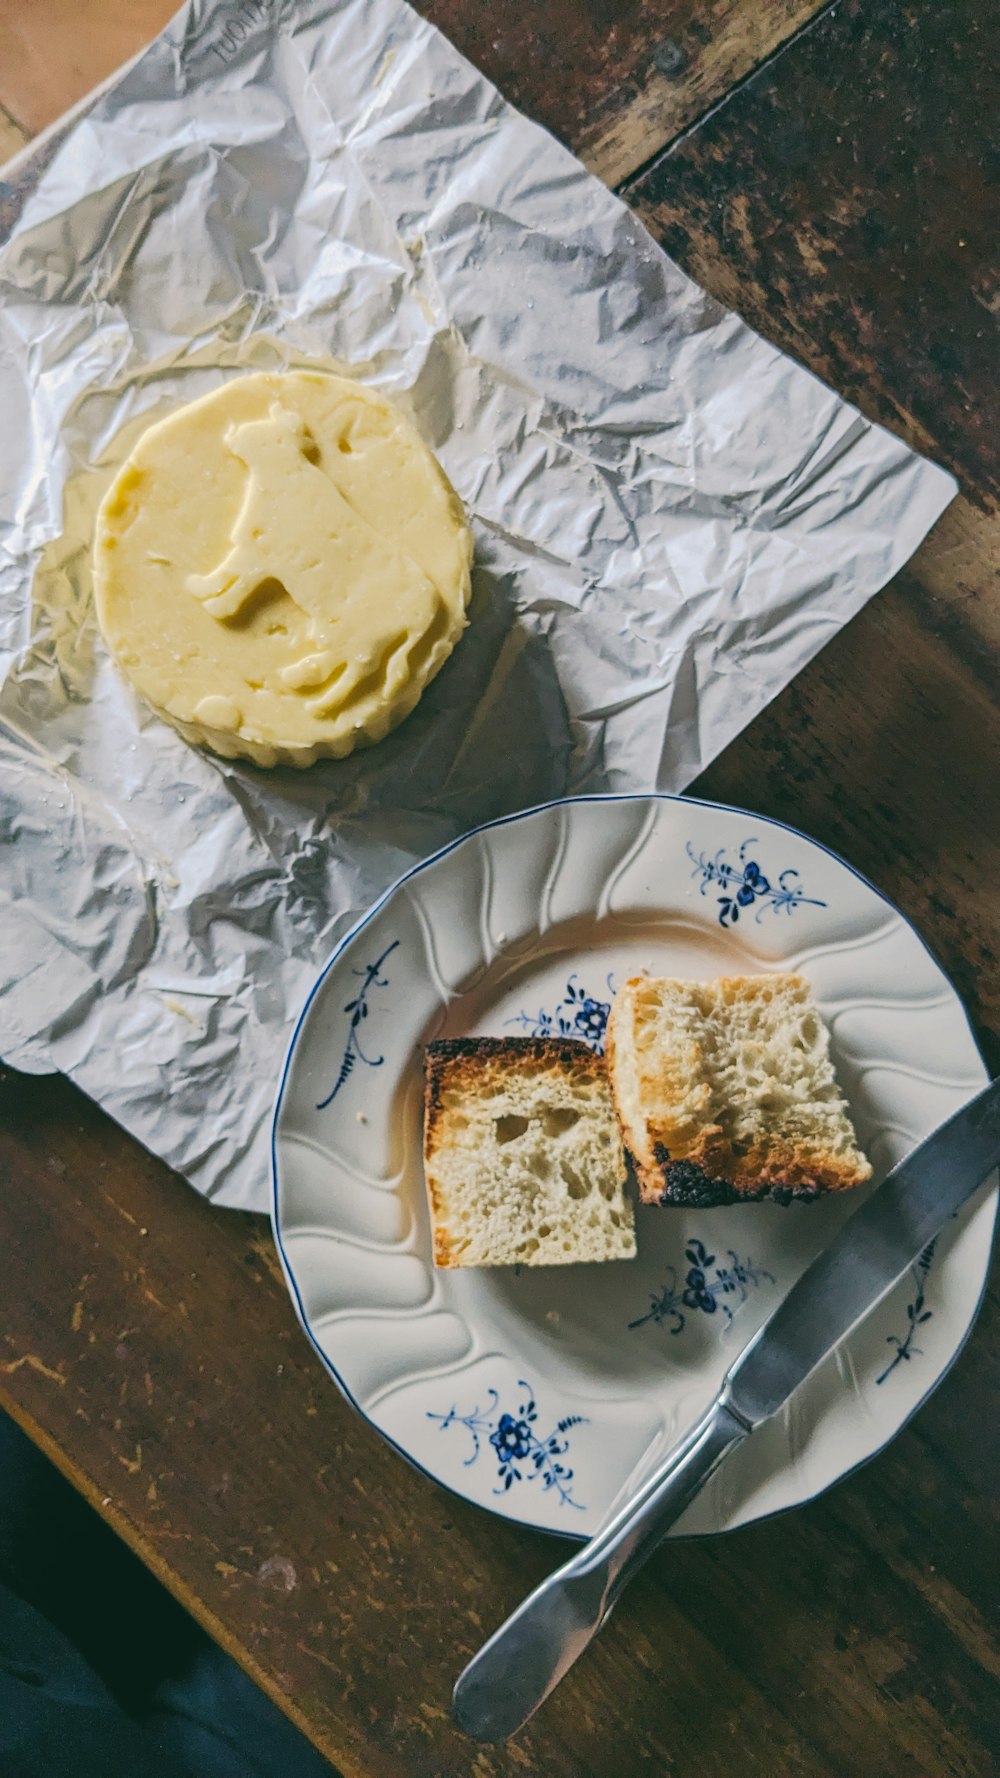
[626,0,1000,503]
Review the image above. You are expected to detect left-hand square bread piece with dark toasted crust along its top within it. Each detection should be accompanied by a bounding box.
[423,1037,635,1266]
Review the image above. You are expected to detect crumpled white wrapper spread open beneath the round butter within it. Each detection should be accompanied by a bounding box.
[0,0,954,1209]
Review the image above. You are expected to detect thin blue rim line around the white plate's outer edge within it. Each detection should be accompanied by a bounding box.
[270,789,1000,1543]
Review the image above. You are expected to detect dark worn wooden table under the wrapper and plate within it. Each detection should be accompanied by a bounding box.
[0,0,1000,1778]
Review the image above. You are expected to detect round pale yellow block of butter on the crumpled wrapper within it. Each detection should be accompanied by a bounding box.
[94,372,472,765]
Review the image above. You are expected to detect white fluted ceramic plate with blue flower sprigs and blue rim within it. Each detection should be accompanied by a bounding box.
[274,797,996,1536]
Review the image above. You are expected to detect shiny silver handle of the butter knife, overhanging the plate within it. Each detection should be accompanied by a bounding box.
[452,1392,749,1741]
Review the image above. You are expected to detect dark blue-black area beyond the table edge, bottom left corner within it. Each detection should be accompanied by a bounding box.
[0,1414,336,1778]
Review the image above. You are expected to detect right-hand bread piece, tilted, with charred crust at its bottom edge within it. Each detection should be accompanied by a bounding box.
[607,974,872,1205]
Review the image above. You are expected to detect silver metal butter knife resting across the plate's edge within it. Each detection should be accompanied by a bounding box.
[452,1079,1000,1741]
